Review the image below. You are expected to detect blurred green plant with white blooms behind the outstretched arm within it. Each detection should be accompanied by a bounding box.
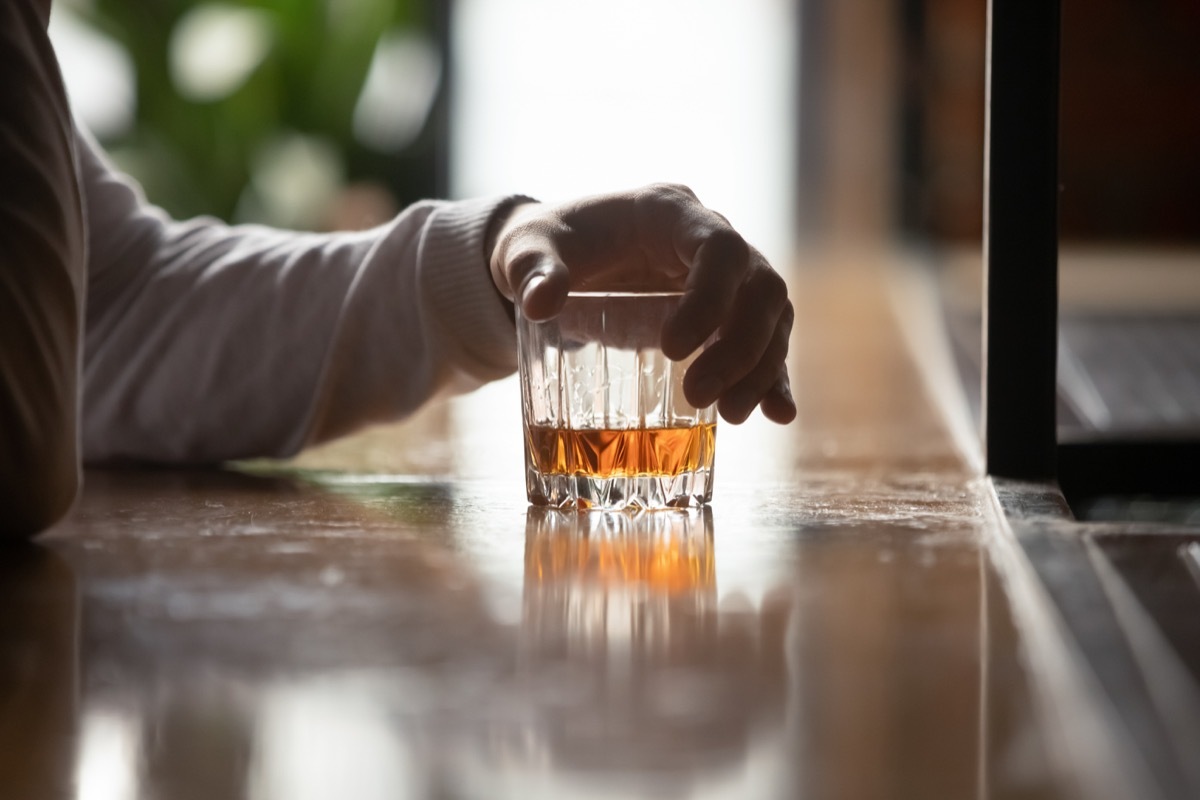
[50,0,444,229]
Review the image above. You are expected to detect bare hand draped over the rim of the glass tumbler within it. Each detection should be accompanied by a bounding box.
[490,184,796,423]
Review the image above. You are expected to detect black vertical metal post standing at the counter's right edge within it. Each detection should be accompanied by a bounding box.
[983,0,1061,480]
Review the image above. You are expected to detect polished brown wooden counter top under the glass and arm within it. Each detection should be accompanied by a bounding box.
[0,259,1152,800]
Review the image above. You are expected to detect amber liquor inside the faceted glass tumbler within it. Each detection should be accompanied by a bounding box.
[528,422,716,477]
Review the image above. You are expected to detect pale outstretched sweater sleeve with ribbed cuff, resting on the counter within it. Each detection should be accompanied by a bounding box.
[79,134,516,463]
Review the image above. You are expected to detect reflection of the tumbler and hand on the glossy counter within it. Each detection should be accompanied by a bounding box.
[508,507,784,788]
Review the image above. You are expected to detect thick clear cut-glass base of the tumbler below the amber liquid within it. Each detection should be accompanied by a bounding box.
[526,468,713,511]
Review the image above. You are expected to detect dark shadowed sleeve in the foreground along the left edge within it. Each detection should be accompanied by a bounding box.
[0,0,86,537]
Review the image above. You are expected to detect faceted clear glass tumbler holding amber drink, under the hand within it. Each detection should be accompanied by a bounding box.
[517,291,716,510]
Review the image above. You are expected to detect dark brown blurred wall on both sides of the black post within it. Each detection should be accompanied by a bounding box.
[896,0,1200,243]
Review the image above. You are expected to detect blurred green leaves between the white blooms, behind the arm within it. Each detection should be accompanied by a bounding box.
[76,0,436,222]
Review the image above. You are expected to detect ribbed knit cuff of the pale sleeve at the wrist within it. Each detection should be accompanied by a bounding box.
[420,197,517,380]
